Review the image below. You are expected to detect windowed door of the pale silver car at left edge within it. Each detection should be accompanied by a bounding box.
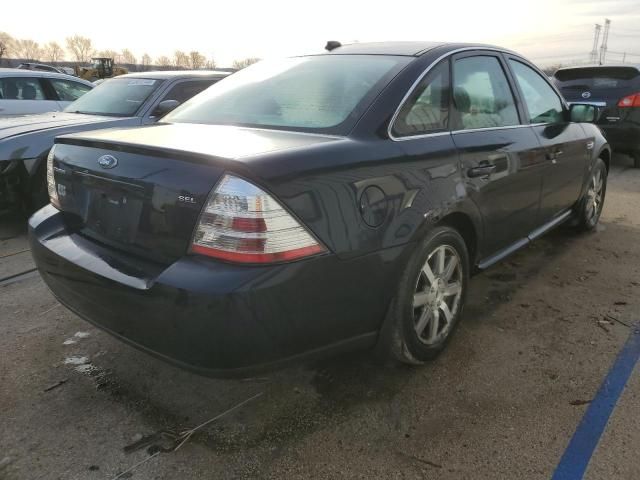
[0,77,60,117]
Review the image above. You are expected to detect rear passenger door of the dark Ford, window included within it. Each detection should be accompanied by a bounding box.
[452,52,543,257]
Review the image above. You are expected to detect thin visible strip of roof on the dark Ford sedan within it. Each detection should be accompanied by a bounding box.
[325,41,510,57]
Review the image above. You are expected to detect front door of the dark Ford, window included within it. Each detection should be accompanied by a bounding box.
[508,57,589,224]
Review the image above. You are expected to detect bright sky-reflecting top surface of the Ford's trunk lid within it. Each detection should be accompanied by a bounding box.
[60,123,342,160]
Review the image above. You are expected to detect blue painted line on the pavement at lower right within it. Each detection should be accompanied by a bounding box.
[552,325,640,480]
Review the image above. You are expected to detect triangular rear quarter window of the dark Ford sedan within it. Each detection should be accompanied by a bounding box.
[391,60,449,137]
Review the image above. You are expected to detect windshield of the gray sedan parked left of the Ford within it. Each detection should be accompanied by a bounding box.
[64,78,162,117]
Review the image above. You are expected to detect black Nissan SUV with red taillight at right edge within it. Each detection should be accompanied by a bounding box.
[554,64,640,168]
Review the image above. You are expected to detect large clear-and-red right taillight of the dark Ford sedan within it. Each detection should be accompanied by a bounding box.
[191,175,326,263]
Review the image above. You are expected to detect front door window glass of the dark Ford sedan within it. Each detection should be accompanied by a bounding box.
[509,60,563,123]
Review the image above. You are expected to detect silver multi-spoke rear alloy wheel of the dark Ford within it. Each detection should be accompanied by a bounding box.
[413,245,463,345]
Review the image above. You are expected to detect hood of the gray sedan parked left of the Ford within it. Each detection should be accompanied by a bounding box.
[0,112,140,161]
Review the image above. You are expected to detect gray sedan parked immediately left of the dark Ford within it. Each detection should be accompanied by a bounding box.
[0,71,229,209]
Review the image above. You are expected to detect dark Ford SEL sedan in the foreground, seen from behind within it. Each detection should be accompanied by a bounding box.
[29,42,611,376]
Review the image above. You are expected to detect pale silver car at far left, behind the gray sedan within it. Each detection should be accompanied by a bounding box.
[0,68,93,119]
